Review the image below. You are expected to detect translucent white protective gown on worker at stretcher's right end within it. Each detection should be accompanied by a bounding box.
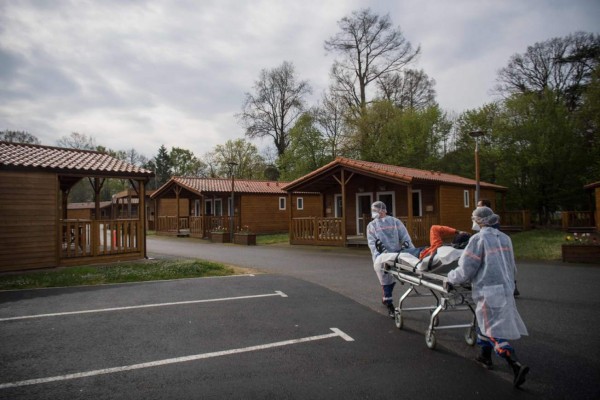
[448,226,528,339]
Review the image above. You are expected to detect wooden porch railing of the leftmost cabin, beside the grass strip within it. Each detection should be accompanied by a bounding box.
[59,219,142,259]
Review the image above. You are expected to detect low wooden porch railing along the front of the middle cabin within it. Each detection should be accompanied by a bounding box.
[156,215,240,238]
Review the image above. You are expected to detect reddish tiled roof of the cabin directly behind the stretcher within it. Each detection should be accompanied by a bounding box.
[284,157,506,190]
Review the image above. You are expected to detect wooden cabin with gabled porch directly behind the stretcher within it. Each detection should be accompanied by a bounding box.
[283,157,506,246]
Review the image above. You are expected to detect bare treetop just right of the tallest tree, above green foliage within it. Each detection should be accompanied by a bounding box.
[377,69,435,110]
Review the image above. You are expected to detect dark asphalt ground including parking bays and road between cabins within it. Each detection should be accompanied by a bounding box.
[0,238,600,399]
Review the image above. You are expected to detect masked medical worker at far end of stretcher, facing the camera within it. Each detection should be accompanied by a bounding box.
[367,201,415,318]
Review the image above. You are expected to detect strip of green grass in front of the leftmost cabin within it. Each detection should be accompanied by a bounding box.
[0,260,235,290]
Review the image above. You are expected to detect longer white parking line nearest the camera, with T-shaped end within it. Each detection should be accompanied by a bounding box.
[0,328,354,389]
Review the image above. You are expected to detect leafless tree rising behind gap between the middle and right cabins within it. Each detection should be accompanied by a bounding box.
[238,61,311,156]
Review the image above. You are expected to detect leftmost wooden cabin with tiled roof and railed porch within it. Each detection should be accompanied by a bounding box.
[0,142,154,272]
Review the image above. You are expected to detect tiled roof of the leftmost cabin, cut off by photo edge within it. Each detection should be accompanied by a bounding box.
[0,142,154,177]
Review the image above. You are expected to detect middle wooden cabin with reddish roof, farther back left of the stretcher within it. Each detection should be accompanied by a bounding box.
[151,176,321,238]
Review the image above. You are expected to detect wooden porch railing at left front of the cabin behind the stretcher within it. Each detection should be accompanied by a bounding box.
[290,217,344,246]
